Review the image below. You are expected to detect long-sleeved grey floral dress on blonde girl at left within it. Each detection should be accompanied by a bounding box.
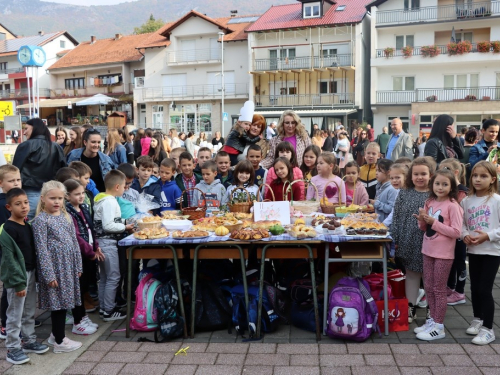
[32,212,82,311]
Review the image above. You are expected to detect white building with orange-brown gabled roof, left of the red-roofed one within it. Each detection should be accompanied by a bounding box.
[134,11,257,134]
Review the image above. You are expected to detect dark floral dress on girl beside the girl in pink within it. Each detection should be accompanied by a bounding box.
[391,189,429,273]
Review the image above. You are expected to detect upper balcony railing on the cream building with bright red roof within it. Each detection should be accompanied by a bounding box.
[254,54,353,71]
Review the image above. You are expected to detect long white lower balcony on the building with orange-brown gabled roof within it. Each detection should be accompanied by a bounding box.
[134,83,248,102]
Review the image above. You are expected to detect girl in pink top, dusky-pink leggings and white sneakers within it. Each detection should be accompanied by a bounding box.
[413,169,463,341]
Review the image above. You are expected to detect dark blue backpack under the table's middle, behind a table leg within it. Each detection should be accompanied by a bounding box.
[231,284,279,337]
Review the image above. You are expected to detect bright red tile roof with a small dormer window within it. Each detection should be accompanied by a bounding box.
[247,0,372,32]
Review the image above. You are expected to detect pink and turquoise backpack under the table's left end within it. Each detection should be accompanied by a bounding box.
[130,273,161,332]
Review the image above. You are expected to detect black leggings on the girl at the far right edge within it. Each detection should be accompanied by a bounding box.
[469,254,500,329]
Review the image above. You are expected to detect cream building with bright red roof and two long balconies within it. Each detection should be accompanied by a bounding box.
[247,0,371,130]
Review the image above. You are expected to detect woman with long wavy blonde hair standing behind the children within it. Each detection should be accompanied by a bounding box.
[261,110,311,169]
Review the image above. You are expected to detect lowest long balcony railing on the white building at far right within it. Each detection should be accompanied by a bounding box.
[377,86,500,104]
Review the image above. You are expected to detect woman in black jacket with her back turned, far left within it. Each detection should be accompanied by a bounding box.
[12,118,66,219]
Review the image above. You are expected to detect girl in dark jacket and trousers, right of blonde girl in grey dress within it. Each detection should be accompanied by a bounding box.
[64,179,104,335]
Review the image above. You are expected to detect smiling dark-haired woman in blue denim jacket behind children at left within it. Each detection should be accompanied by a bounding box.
[68,129,114,193]
